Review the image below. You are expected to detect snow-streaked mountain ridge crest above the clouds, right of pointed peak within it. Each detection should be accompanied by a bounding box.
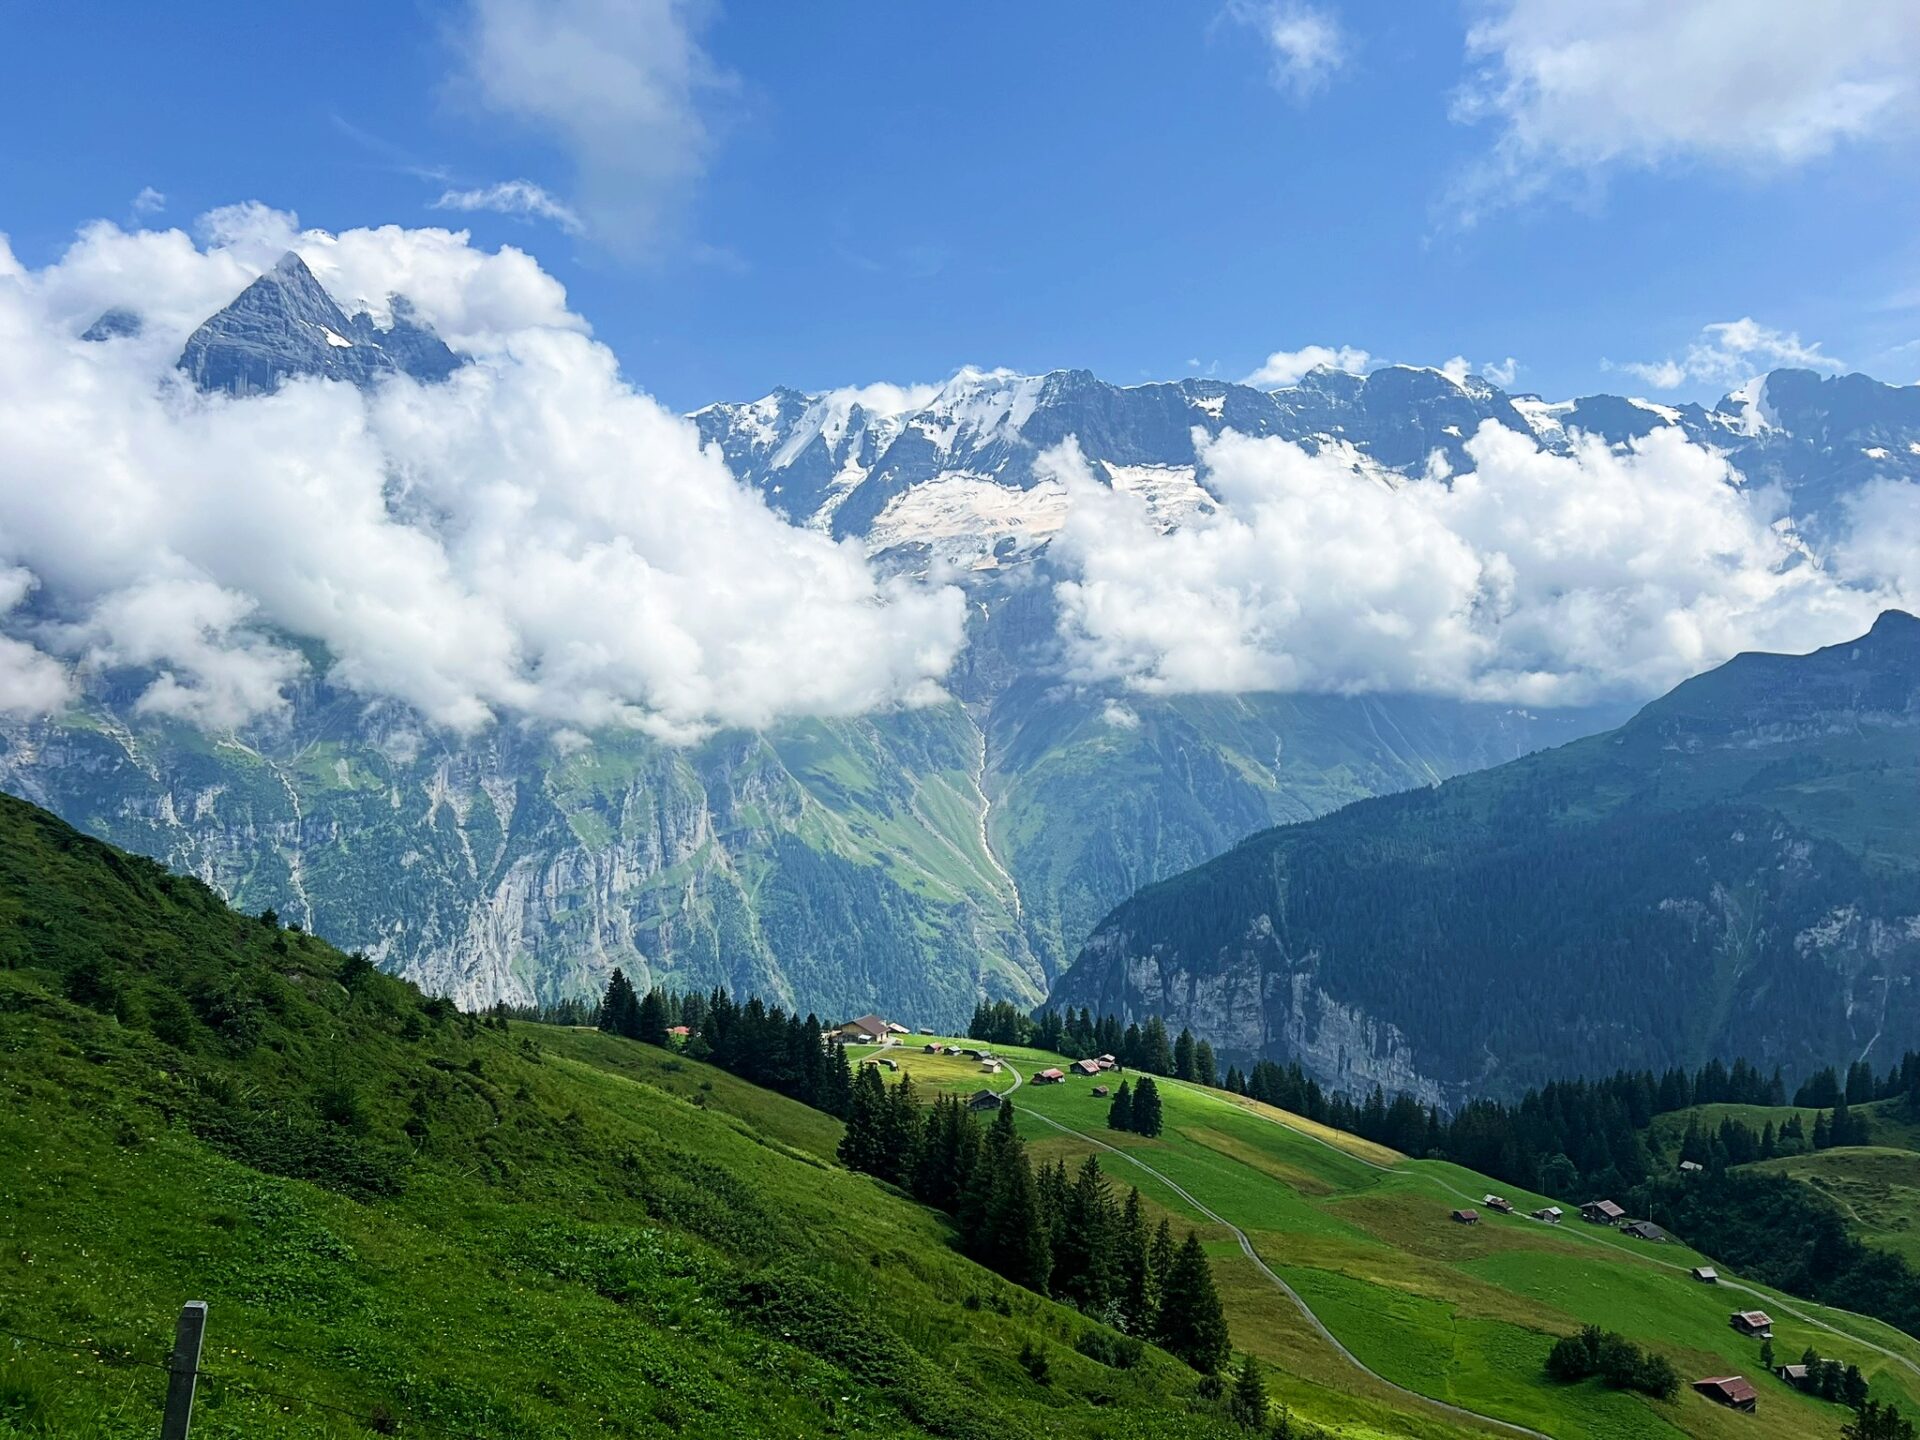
[689,365,1920,570]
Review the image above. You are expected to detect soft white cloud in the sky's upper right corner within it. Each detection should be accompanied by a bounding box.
[1453,0,1920,221]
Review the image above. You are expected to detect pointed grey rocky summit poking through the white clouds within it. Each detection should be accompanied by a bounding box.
[180,250,461,396]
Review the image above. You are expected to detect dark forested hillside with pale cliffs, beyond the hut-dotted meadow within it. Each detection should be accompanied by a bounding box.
[1052,612,1920,1100]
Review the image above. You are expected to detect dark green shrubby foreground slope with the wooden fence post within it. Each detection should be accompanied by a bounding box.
[0,801,1259,1440]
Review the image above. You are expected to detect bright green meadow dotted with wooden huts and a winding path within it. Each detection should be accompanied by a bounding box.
[864,1046,1920,1438]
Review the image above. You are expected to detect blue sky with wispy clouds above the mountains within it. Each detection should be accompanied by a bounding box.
[0,0,1920,407]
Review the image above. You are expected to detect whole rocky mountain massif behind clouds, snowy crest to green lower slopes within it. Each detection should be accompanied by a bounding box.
[0,255,1920,1025]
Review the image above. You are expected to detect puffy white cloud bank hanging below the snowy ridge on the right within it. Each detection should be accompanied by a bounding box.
[1050,422,1910,705]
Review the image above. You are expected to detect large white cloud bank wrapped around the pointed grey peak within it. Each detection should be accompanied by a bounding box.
[0,207,964,739]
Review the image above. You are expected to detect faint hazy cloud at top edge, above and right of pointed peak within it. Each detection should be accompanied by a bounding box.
[449,0,733,253]
